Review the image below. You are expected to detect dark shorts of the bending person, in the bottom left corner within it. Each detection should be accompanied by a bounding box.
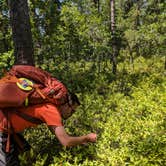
[0,132,20,166]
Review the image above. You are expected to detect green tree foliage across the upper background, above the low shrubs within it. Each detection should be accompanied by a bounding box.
[0,0,166,70]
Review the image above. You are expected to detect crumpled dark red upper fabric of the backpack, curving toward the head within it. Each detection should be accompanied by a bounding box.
[8,65,68,105]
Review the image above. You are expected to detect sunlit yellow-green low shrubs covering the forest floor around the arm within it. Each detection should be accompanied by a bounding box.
[20,58,166,166]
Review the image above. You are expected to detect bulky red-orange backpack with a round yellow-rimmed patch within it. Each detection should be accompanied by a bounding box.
[0,65,68,108]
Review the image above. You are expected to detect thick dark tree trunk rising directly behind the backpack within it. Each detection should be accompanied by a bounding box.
[9,0,34,65]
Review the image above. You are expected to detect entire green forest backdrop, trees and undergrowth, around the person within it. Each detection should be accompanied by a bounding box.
[0,0,166,166]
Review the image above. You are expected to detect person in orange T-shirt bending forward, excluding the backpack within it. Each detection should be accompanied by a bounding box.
[0,93,97,166]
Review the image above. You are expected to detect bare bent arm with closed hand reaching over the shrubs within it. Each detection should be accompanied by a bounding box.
[50,126,97,147]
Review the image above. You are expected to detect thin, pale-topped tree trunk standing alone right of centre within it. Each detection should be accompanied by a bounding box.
[110,0,117,74]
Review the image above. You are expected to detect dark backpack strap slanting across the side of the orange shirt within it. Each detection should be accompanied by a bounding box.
[11,110,43,124]
